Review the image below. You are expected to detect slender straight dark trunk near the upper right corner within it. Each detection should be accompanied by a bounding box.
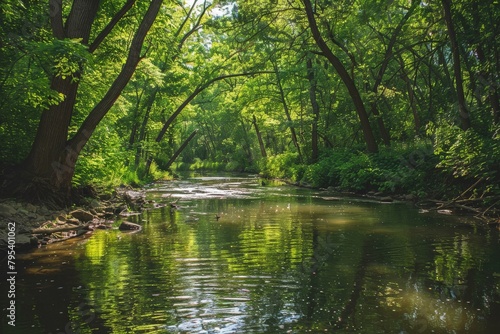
[442,0,471,131]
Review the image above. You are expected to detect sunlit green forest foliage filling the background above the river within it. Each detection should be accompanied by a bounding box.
[0,0,500,214]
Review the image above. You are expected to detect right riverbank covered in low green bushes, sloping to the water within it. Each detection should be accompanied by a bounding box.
[254,147,500,226]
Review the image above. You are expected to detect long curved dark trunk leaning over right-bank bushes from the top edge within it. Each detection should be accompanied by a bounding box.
[302,0,378,153]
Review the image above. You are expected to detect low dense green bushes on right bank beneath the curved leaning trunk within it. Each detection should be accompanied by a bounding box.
[304,144,436,196]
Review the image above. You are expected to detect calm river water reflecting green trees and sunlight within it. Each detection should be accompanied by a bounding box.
[1,177,500,334]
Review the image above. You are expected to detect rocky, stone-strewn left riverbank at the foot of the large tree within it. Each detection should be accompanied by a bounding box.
[0,188,147,251]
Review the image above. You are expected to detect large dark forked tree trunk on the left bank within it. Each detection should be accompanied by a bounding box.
[6,0,162,203]
